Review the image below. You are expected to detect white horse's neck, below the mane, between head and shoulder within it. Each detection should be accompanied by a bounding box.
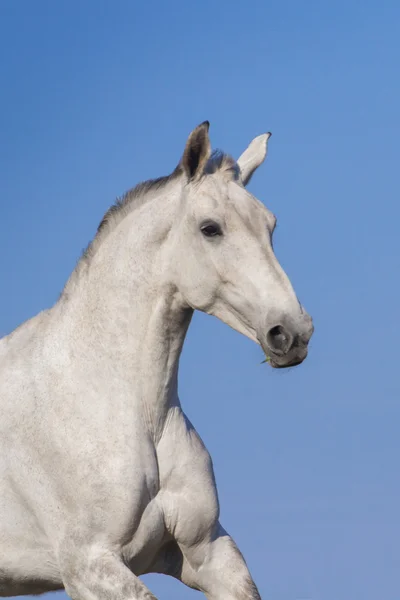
[57,186,192,439]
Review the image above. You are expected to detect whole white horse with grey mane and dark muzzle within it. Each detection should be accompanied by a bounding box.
[0,122,313,600]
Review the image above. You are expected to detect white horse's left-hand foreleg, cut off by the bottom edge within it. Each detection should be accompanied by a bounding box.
[59,543,157,600]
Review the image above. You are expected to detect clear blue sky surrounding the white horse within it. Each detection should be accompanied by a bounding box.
[0,0,400,600]
